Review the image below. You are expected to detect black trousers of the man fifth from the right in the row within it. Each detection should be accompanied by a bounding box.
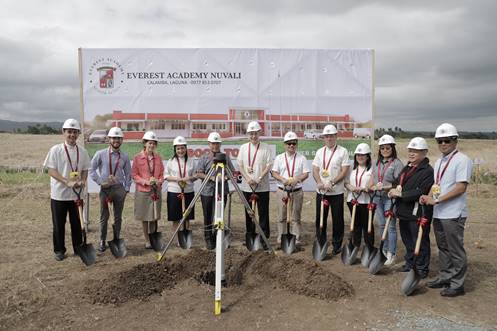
[316,194,344,249]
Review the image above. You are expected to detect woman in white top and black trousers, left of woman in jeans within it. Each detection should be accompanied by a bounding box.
[345,143,374,247]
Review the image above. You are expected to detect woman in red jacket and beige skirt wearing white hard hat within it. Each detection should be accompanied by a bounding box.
[131,131,164,249]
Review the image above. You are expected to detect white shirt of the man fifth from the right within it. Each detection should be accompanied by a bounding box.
[312,145,350,195]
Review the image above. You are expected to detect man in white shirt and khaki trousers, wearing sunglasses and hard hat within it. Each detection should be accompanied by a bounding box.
[271,131,310,245]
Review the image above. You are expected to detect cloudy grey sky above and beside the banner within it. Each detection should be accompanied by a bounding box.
[0,0,497,131]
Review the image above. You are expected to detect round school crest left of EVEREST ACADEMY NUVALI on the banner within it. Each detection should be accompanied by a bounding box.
[88,58,124,94]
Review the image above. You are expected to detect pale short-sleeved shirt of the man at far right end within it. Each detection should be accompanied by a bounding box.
[433,152,473,219]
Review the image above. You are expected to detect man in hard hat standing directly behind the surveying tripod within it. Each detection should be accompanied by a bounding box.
[196,132,234,249]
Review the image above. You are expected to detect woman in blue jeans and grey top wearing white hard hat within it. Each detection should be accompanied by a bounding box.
[371,134,404,266]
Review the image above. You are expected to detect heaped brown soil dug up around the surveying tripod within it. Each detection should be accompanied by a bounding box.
[84,249,353,304]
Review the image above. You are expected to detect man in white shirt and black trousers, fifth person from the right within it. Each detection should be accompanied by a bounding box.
[312,124,350,254]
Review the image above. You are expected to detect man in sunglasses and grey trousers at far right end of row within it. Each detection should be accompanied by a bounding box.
[420,123,473,297]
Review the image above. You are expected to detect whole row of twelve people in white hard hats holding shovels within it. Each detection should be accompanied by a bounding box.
[44,119,472,296]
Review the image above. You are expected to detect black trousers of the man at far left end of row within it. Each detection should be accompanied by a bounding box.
[50,199,83,254]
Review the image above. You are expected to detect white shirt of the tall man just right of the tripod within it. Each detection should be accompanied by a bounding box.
[237,142,272,192]
